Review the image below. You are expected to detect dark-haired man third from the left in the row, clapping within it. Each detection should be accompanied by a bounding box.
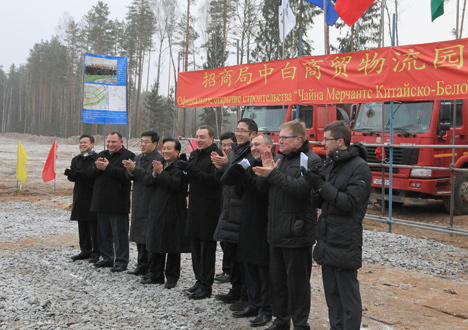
[122,131,164,275]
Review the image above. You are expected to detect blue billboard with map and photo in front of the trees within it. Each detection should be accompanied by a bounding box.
[81,53,127,124]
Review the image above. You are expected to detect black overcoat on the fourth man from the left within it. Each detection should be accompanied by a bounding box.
[146,164,190,253]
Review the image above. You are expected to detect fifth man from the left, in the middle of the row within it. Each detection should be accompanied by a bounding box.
[174,125,221,299]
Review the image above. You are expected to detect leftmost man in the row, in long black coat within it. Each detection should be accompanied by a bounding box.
[64,134,100,263]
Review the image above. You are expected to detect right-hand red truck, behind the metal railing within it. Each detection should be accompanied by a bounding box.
[352,100,468,215]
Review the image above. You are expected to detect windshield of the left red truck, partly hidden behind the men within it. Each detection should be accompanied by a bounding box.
[243,105,288,132]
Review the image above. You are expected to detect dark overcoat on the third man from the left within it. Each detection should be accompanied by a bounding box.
[126,150,164,244]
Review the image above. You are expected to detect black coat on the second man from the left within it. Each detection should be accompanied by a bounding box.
[89,147,135,214]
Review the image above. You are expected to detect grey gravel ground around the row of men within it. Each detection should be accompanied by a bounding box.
[0,201,468,329]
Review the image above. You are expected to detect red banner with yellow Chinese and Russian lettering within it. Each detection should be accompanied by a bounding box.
[177,39,468,108]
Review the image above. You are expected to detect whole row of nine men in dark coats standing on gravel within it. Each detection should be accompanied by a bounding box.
[66,119,371,330]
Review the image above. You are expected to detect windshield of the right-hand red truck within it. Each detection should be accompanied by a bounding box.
[353,101,434,134]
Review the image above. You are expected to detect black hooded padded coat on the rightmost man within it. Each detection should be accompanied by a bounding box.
[313,142,372,270]
